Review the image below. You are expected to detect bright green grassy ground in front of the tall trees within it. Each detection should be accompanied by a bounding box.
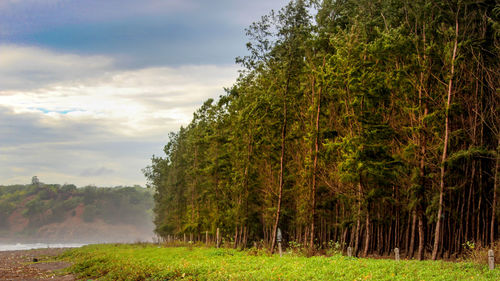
[62,245,500,281]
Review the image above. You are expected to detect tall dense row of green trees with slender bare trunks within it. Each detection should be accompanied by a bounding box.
[145,0,500,259]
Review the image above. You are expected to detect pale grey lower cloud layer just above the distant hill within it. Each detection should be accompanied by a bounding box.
[0,103,165,186]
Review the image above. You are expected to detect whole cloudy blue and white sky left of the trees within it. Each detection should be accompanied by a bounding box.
[0,0,288,186]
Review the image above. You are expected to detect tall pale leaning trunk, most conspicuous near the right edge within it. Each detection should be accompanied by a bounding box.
[432,13,458,260]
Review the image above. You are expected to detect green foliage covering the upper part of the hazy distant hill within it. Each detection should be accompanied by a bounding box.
[0,184,153,230]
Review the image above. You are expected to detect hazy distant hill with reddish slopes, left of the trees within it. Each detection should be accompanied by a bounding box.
[0,182,153,243]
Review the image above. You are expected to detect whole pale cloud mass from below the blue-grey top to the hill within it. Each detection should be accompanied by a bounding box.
[0,46,237,185]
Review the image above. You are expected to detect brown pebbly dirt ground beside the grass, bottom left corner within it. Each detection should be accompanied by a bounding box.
[0,249,75,281]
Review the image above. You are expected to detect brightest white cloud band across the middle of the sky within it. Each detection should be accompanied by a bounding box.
[0,45,238,128]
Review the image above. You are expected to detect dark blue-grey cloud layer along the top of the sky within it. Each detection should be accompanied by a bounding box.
[0,0,288,68]
